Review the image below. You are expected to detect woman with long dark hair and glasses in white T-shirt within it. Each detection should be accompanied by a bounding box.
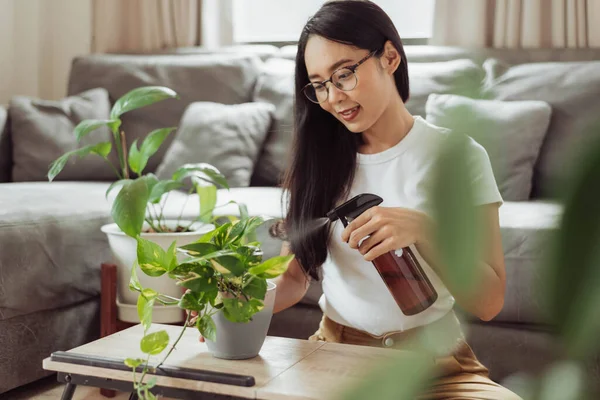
[275,0,518,399]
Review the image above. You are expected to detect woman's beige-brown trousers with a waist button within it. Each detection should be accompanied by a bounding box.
[309,312,522,400]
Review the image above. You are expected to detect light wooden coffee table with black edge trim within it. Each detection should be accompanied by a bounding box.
[43,324,398,400]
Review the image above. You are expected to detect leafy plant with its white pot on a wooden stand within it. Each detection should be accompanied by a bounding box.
[48,86,228,323]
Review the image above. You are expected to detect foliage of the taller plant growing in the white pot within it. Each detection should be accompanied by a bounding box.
[48,86,229,234]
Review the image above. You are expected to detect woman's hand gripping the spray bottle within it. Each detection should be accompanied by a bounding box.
[342,207,431,261]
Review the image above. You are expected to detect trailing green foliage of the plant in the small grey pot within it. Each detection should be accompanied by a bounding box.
[125,214,294,399]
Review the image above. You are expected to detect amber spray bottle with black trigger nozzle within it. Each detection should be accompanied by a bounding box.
[327,193,438,315]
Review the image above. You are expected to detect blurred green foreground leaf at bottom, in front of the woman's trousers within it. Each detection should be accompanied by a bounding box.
[339,351,435,400]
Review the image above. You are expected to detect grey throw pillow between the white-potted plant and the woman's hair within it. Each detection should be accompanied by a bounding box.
[156,102,275,187]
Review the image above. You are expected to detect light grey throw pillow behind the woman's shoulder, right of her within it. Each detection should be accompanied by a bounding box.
[426,94,552,201]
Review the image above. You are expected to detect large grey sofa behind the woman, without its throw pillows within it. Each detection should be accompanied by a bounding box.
[0,46,600,393]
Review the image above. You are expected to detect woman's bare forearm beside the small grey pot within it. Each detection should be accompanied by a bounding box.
[273,242,310,313]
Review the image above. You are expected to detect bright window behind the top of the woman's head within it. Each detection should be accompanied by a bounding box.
[233,0,435,43]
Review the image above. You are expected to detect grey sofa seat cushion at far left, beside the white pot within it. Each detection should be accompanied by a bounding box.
[0,182,111,320]
